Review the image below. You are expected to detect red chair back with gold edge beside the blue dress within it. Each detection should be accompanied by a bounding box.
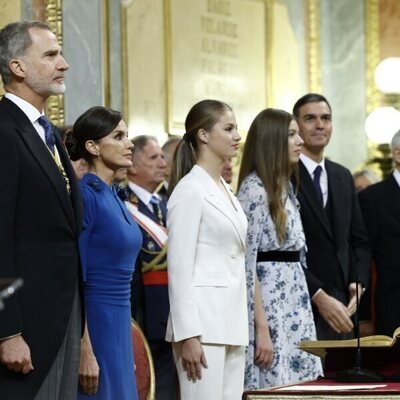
[132,319,155,400]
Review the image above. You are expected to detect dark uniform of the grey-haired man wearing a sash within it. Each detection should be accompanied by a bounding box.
[128,187,169,340]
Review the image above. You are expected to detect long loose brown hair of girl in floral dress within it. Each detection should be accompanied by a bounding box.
[238,108,293,241]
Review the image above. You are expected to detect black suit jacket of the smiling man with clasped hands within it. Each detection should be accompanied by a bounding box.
[298,160,370,297]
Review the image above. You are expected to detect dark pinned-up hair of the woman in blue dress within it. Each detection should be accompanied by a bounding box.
[66,106,122,163]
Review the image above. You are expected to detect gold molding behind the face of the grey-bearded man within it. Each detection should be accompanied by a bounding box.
[44,0,65,126]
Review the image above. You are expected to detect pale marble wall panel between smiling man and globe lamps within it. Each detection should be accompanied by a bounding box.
[321,0,367,169]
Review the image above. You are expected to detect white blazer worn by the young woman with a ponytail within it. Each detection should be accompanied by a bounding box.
[166,165,248,346]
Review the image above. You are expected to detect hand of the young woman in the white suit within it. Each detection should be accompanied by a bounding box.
[182,337,207,382]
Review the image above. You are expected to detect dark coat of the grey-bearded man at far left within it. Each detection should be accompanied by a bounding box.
[0,98,82,400]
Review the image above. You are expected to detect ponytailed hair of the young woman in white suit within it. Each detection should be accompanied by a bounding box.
[168,100,232,194]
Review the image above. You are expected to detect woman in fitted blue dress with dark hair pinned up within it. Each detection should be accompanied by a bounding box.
[68,107,142,400]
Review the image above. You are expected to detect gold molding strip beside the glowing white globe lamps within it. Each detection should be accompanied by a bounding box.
[364,0,382,114]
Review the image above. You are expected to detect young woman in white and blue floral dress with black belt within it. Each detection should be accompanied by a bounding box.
[238,109,322,389]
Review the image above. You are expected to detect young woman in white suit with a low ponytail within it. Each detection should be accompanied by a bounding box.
[166,100,248,400]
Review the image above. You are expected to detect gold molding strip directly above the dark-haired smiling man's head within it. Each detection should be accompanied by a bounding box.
[306,0,322,93]
